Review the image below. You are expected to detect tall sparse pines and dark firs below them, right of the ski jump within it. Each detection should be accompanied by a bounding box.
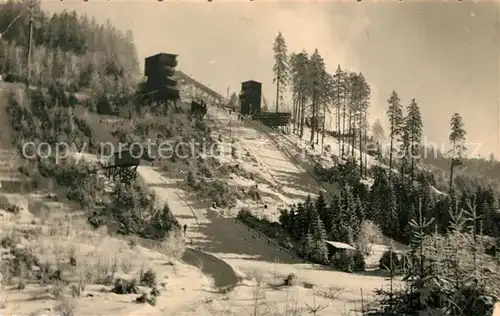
[273,33,500,252]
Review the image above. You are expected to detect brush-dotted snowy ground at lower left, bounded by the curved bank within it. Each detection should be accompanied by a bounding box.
[0,188,212,315]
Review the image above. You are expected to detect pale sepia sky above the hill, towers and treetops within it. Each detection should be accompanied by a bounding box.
[42,0,500,157]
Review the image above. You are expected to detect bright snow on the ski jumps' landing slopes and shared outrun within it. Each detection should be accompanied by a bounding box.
[114,105,398,315]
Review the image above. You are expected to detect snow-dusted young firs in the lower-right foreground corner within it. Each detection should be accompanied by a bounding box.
[378,201,499,315]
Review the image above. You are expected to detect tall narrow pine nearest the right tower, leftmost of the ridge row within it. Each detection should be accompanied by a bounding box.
[273,32,289,112]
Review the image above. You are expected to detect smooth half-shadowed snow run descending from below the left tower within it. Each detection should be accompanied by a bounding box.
[137,166,301,263]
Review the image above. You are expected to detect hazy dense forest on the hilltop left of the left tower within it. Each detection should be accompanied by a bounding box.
[0,0,140,111]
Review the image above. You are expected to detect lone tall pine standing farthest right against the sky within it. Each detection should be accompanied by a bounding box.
[449,113,467,191]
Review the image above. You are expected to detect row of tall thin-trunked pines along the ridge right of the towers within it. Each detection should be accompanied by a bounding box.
[273,33,500,194]
